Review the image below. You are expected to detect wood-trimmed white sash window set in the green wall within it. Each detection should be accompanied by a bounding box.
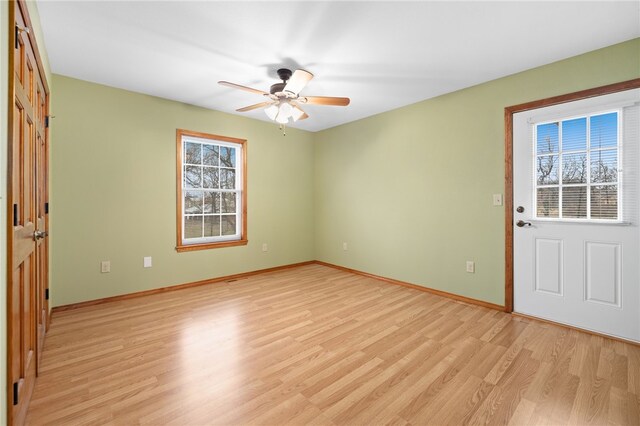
[176,130,247,251]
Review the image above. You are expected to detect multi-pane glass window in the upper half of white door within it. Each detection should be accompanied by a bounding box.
[534,111,622,221]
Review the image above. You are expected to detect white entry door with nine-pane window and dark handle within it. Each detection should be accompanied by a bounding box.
[513,90,640,341]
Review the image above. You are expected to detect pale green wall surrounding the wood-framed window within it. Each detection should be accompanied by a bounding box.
[50,75,314,306]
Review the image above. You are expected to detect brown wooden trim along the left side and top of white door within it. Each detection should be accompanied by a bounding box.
[504,78,640,312]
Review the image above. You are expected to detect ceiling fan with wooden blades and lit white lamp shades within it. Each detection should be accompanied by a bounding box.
[218,68,351,126]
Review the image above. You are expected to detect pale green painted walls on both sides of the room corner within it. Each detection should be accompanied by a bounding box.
[51,39,640,306]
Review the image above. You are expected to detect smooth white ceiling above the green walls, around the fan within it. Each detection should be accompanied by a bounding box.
[38,0,640,131]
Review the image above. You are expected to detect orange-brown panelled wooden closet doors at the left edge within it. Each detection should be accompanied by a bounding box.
[7,2,48,424]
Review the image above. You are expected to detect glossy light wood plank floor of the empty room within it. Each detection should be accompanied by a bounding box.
[27,265,640,425]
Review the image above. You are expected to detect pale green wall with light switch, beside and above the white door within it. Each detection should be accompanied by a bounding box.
[314,39,640,305]
